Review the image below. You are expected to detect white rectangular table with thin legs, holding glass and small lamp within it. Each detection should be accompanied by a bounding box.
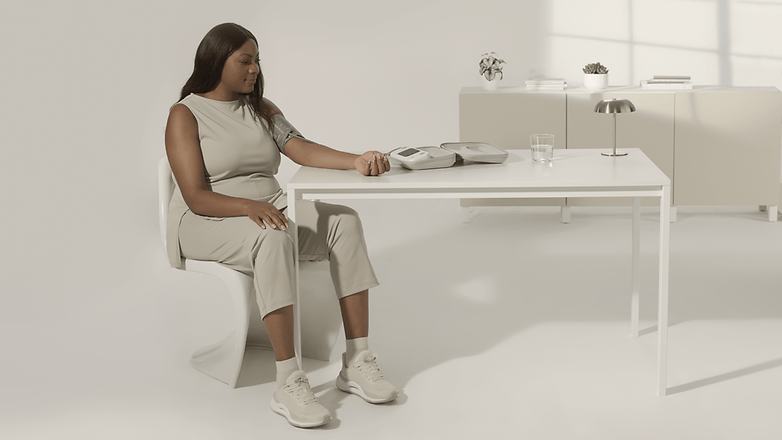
[288,149,671,395]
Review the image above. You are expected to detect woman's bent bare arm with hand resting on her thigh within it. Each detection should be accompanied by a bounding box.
[166,104,288,229]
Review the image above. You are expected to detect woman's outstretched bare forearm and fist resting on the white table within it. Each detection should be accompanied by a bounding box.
[285,137,391,176]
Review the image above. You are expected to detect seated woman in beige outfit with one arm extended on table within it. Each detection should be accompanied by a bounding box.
[166,23,398,427]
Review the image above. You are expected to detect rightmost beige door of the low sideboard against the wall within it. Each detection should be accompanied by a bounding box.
[673,87,782,206]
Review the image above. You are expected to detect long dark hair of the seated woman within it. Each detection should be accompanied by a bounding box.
[179,23,271,127]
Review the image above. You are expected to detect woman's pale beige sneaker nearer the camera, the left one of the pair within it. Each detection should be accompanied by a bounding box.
[271,370,331,428]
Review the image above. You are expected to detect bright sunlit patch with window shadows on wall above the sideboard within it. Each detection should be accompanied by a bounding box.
[548,0,782,86]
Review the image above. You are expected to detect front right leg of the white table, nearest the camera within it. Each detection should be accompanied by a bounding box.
[657,186,671,396]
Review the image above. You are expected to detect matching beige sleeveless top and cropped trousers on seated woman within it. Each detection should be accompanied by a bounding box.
[166,95,378,316]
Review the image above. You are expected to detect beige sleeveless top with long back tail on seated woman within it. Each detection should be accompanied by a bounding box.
[166,94,304,269]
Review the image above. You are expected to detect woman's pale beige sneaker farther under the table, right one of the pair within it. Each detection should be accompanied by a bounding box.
[337,350,399,403]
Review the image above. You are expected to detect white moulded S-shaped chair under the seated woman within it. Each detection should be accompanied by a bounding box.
[158,156,342,388]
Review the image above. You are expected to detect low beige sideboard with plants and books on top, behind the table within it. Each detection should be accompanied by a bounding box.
[459,86,782,220]
